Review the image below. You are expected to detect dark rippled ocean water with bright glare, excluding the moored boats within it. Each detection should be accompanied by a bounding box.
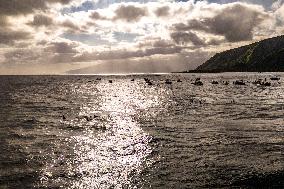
[0,73,284,189]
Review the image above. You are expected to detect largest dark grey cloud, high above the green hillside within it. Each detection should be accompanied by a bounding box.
[174,3,266,42]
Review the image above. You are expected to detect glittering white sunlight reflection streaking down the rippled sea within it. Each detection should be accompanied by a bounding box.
[38,79,168,188]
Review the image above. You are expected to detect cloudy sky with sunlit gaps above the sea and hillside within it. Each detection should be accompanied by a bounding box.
[0,0,284,74]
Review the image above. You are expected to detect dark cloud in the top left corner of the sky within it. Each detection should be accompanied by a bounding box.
[0,0,72,15]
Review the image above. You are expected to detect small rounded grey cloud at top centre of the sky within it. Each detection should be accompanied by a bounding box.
[114,5,148,22]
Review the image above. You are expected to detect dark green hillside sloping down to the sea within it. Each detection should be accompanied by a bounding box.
[195,36,284,72]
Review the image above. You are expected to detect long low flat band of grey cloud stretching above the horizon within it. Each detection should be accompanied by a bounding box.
[5,42,183,63]
